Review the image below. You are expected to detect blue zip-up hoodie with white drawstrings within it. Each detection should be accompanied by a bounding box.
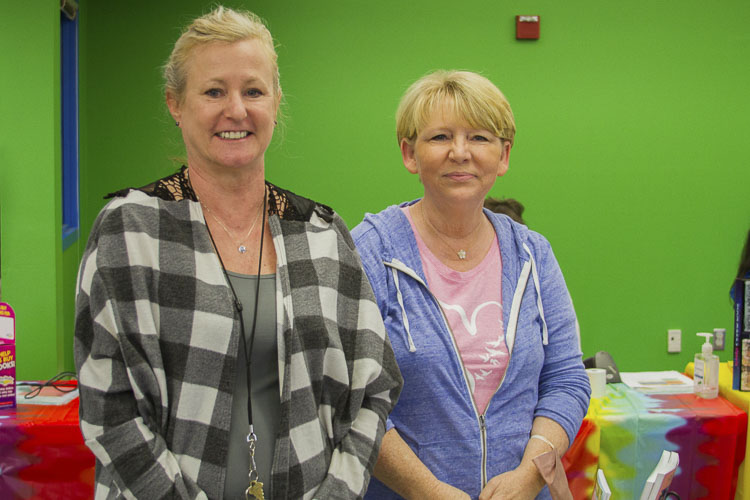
[352,201,590,499]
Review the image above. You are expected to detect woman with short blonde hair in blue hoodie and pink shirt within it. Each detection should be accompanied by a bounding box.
[352,71,590,500]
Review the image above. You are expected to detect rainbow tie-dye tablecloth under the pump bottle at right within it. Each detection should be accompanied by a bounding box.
[563,384,747,500]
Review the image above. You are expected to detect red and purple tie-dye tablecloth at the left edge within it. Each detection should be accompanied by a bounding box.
[0,399,94,500]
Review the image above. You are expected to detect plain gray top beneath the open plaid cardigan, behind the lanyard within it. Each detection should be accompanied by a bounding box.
[224,271,281,499]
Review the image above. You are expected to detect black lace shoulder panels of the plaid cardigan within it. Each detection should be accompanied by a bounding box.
[105,166,333,222]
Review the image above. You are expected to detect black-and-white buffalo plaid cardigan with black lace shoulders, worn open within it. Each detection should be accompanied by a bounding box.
[74,168,402,499]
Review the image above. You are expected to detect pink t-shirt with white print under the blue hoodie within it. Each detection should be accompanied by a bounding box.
[402,207,508,414]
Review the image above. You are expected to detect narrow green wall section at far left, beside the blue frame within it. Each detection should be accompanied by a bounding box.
[0,0,77,379]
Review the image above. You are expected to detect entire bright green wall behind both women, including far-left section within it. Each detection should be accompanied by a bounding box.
[0,0,750,377]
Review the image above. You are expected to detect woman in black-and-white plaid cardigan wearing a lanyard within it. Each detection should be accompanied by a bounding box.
[75,7,401,499]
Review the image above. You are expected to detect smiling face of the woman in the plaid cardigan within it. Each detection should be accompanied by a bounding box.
[167,39,281,174]
